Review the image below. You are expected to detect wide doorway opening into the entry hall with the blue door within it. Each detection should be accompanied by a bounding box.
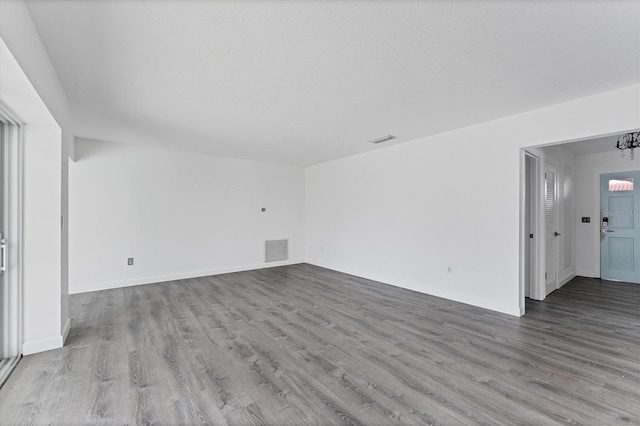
[520,129,640,314]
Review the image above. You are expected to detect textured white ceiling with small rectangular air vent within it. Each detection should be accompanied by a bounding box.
[28,0,640,165]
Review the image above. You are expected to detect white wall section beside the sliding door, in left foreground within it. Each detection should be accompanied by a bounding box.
[0,1,72,354]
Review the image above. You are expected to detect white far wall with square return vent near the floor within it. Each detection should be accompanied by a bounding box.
[69,139,304,293]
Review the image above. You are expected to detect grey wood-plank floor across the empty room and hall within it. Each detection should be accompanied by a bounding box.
[0,264,640,425]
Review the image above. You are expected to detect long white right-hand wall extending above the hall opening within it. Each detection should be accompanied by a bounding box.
[306,85,640,315]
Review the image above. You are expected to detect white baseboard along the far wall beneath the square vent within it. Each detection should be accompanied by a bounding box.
[69,260,304,294]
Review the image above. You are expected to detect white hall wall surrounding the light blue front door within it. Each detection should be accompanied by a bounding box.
[576,149,640,278]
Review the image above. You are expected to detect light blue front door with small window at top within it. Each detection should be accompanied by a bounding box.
[600,171,640,283]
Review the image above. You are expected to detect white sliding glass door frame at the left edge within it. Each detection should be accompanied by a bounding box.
[0,101,23,379]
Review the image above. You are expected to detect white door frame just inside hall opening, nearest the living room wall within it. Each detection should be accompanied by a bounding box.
[520,148,545,315]
